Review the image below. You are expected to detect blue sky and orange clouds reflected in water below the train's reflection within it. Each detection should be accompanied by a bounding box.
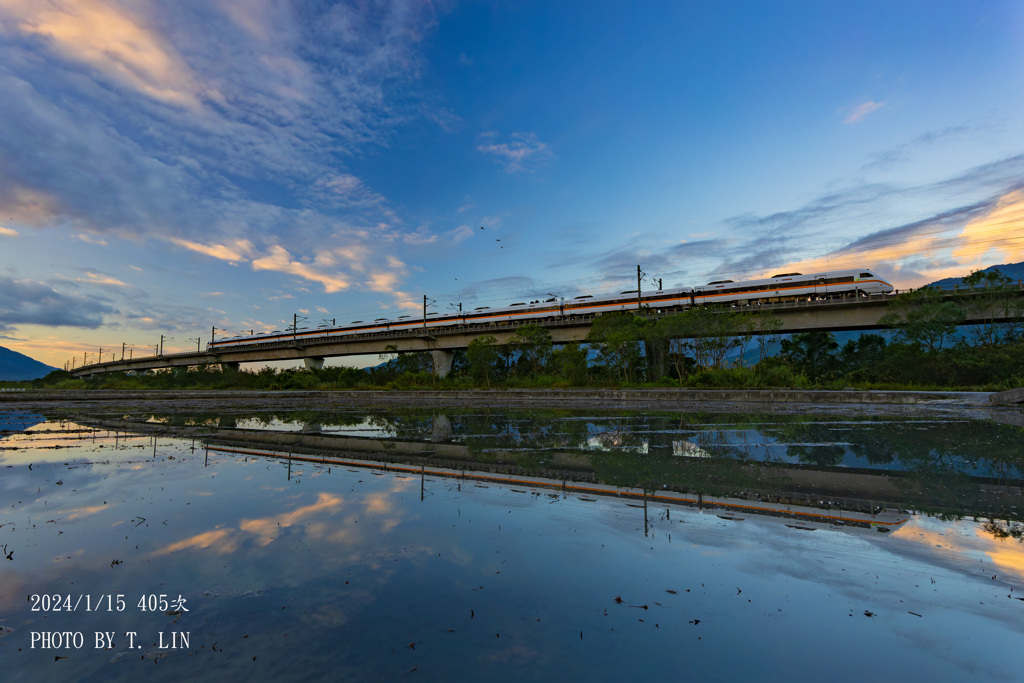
[0,419,1024,681]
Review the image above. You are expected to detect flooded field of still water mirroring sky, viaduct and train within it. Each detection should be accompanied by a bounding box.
[0,408,1024,682]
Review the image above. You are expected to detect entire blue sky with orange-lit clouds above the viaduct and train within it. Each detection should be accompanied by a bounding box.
[0,0,1024,367]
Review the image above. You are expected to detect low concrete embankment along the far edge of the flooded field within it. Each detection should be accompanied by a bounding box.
[0,389,991,410]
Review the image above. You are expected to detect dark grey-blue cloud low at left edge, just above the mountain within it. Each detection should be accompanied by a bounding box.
[0,276,115,330]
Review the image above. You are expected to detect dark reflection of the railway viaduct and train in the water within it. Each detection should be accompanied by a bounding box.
[61,414,1024,519]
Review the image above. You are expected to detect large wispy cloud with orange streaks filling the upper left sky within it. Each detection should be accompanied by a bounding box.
[0,0,442,301]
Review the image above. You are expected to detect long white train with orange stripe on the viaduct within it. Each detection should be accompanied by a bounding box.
[207,269,893,349]
